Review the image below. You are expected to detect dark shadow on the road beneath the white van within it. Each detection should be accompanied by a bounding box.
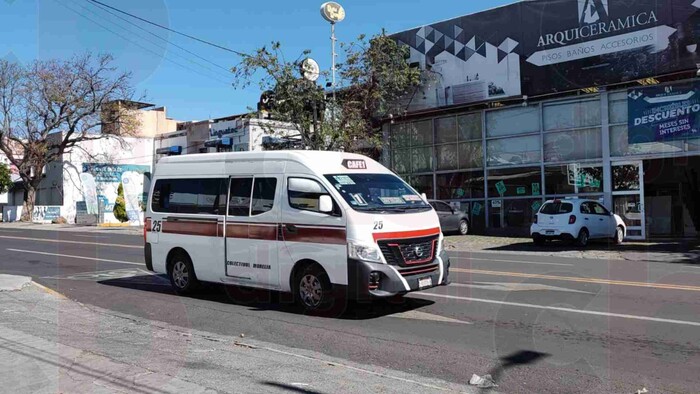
[97,275,435,320]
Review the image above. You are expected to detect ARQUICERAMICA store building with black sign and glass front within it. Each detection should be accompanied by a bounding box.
[383,0,700,239]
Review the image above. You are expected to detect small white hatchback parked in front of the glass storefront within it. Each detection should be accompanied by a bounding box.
[530,199,627,246]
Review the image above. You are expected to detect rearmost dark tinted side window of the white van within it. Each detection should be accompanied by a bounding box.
[151,179,227,215]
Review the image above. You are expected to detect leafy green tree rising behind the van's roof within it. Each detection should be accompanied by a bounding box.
[232,32,421,151]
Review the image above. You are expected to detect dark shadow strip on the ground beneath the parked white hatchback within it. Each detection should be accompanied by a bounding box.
[485,240,700,264]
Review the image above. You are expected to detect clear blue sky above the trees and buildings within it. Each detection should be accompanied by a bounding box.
[0,0,514,120]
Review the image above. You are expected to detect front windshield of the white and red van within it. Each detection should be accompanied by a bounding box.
[326,174,432,212]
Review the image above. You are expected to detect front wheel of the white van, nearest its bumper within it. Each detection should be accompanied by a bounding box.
[294,264,335,312]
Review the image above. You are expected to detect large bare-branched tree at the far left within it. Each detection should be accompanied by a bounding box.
[0,55,138,221]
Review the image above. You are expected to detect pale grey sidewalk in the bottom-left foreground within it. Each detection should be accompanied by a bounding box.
[0,284,476,393]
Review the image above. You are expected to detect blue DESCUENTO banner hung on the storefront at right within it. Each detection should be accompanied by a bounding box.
[627,83,700,144]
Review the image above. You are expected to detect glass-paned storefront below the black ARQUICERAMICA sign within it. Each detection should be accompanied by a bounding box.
[387,83,700,237]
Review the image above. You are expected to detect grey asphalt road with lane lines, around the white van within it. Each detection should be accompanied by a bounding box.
[0,227,700,393]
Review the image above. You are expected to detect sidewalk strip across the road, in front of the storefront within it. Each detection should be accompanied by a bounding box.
[445,235,700,264]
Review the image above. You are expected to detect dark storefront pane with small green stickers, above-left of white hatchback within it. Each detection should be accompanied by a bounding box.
[489,167,542,198]
